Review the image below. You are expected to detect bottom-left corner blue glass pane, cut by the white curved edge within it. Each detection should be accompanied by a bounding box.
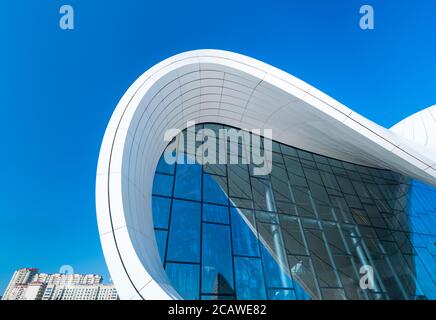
[166,263,200,300]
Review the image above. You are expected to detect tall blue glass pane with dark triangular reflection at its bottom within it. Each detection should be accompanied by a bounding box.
[201,223,234,295]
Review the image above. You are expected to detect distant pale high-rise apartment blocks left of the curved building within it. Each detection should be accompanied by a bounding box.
[2,268,118,300]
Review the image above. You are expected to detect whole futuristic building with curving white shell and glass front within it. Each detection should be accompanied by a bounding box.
[96,50,436,299]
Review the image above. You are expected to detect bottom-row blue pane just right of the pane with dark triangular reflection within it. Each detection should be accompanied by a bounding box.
[234,257,266,300]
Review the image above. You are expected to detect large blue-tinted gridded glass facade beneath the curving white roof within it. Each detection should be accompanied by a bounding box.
[153,124,436,300]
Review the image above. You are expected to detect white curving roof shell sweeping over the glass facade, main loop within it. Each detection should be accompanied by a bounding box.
[96,50,436,299]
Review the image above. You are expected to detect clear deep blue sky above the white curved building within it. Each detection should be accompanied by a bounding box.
[0,0,436,292]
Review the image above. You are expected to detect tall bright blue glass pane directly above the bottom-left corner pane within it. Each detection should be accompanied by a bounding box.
[167,200,201,262]
